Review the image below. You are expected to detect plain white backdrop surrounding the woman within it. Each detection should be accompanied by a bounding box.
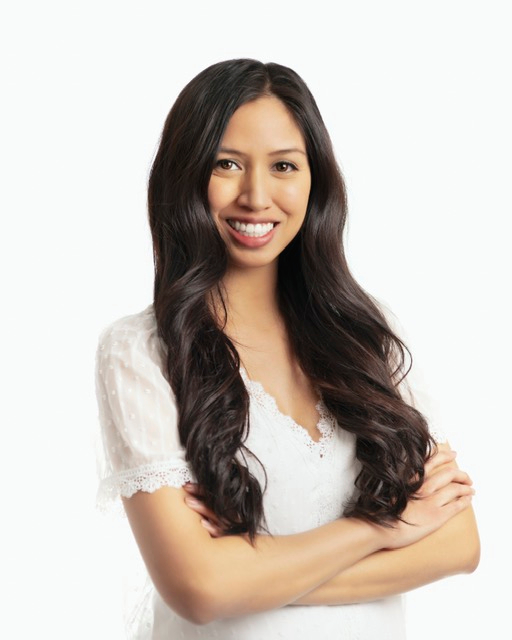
[0,0,512,640]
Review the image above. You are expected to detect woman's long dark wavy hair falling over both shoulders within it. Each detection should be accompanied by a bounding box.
[148,59,434,540]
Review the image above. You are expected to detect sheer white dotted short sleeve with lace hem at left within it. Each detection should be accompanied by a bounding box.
[95,306,194,508]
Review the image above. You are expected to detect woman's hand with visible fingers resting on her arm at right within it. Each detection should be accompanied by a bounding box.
[380,444,475,549]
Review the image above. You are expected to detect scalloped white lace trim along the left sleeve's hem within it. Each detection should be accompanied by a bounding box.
[97,462,194,510]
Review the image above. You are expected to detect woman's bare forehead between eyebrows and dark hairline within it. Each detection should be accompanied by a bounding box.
[222,96,306,152]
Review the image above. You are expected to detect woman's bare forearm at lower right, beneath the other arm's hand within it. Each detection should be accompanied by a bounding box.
[293,509,480,605]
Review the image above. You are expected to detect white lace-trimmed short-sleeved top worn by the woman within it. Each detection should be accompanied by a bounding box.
[96,305,444,640]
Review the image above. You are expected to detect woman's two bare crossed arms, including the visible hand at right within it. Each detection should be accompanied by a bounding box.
[124,449,479,624]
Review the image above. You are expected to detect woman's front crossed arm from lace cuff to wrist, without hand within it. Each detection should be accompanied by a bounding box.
[124,487,387,624]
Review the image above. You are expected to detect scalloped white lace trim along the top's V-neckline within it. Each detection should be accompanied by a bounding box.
[240,367,336,458]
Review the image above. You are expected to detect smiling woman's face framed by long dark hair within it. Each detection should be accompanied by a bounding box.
[208,96,311,268]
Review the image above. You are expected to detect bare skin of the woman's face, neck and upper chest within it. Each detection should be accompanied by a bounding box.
[208,97,320,432]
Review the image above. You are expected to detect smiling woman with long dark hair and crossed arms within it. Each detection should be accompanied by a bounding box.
[97,60,479,640]
